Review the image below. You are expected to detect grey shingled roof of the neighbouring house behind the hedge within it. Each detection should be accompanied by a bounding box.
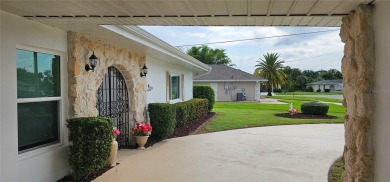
[194,64,267,82]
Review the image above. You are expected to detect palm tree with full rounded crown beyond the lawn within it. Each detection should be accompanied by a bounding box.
[254,52,286,96]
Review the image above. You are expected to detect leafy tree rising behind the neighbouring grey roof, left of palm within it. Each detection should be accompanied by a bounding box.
[187,45,232,65]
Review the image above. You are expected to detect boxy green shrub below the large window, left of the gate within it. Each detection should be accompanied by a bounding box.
[66,117,114,181]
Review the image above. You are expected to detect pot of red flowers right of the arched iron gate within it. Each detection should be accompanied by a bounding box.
[131,122,152,150]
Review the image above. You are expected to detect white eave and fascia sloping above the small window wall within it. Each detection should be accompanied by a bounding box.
[101,25,211,71]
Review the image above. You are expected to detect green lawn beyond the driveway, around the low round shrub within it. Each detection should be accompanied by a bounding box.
[205,97,345,132]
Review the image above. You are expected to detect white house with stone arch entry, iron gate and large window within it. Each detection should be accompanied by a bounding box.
[0,11,211,182]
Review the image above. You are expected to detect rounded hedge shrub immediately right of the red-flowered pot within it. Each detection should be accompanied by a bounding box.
[148,103,176,141]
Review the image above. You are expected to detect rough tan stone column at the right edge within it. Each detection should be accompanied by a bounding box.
[340,5,375,181]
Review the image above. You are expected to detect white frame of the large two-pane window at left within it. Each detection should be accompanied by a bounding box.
[15,45,67,160]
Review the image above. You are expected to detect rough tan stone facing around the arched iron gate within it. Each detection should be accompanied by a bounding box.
[68,32,146,121]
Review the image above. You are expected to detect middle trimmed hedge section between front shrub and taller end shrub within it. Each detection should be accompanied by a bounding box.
[174,99,208,128]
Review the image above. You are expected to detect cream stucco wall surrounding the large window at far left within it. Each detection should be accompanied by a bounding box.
[0,11,69,182]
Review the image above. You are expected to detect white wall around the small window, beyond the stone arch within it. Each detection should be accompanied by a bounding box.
[146,55,193,104]
